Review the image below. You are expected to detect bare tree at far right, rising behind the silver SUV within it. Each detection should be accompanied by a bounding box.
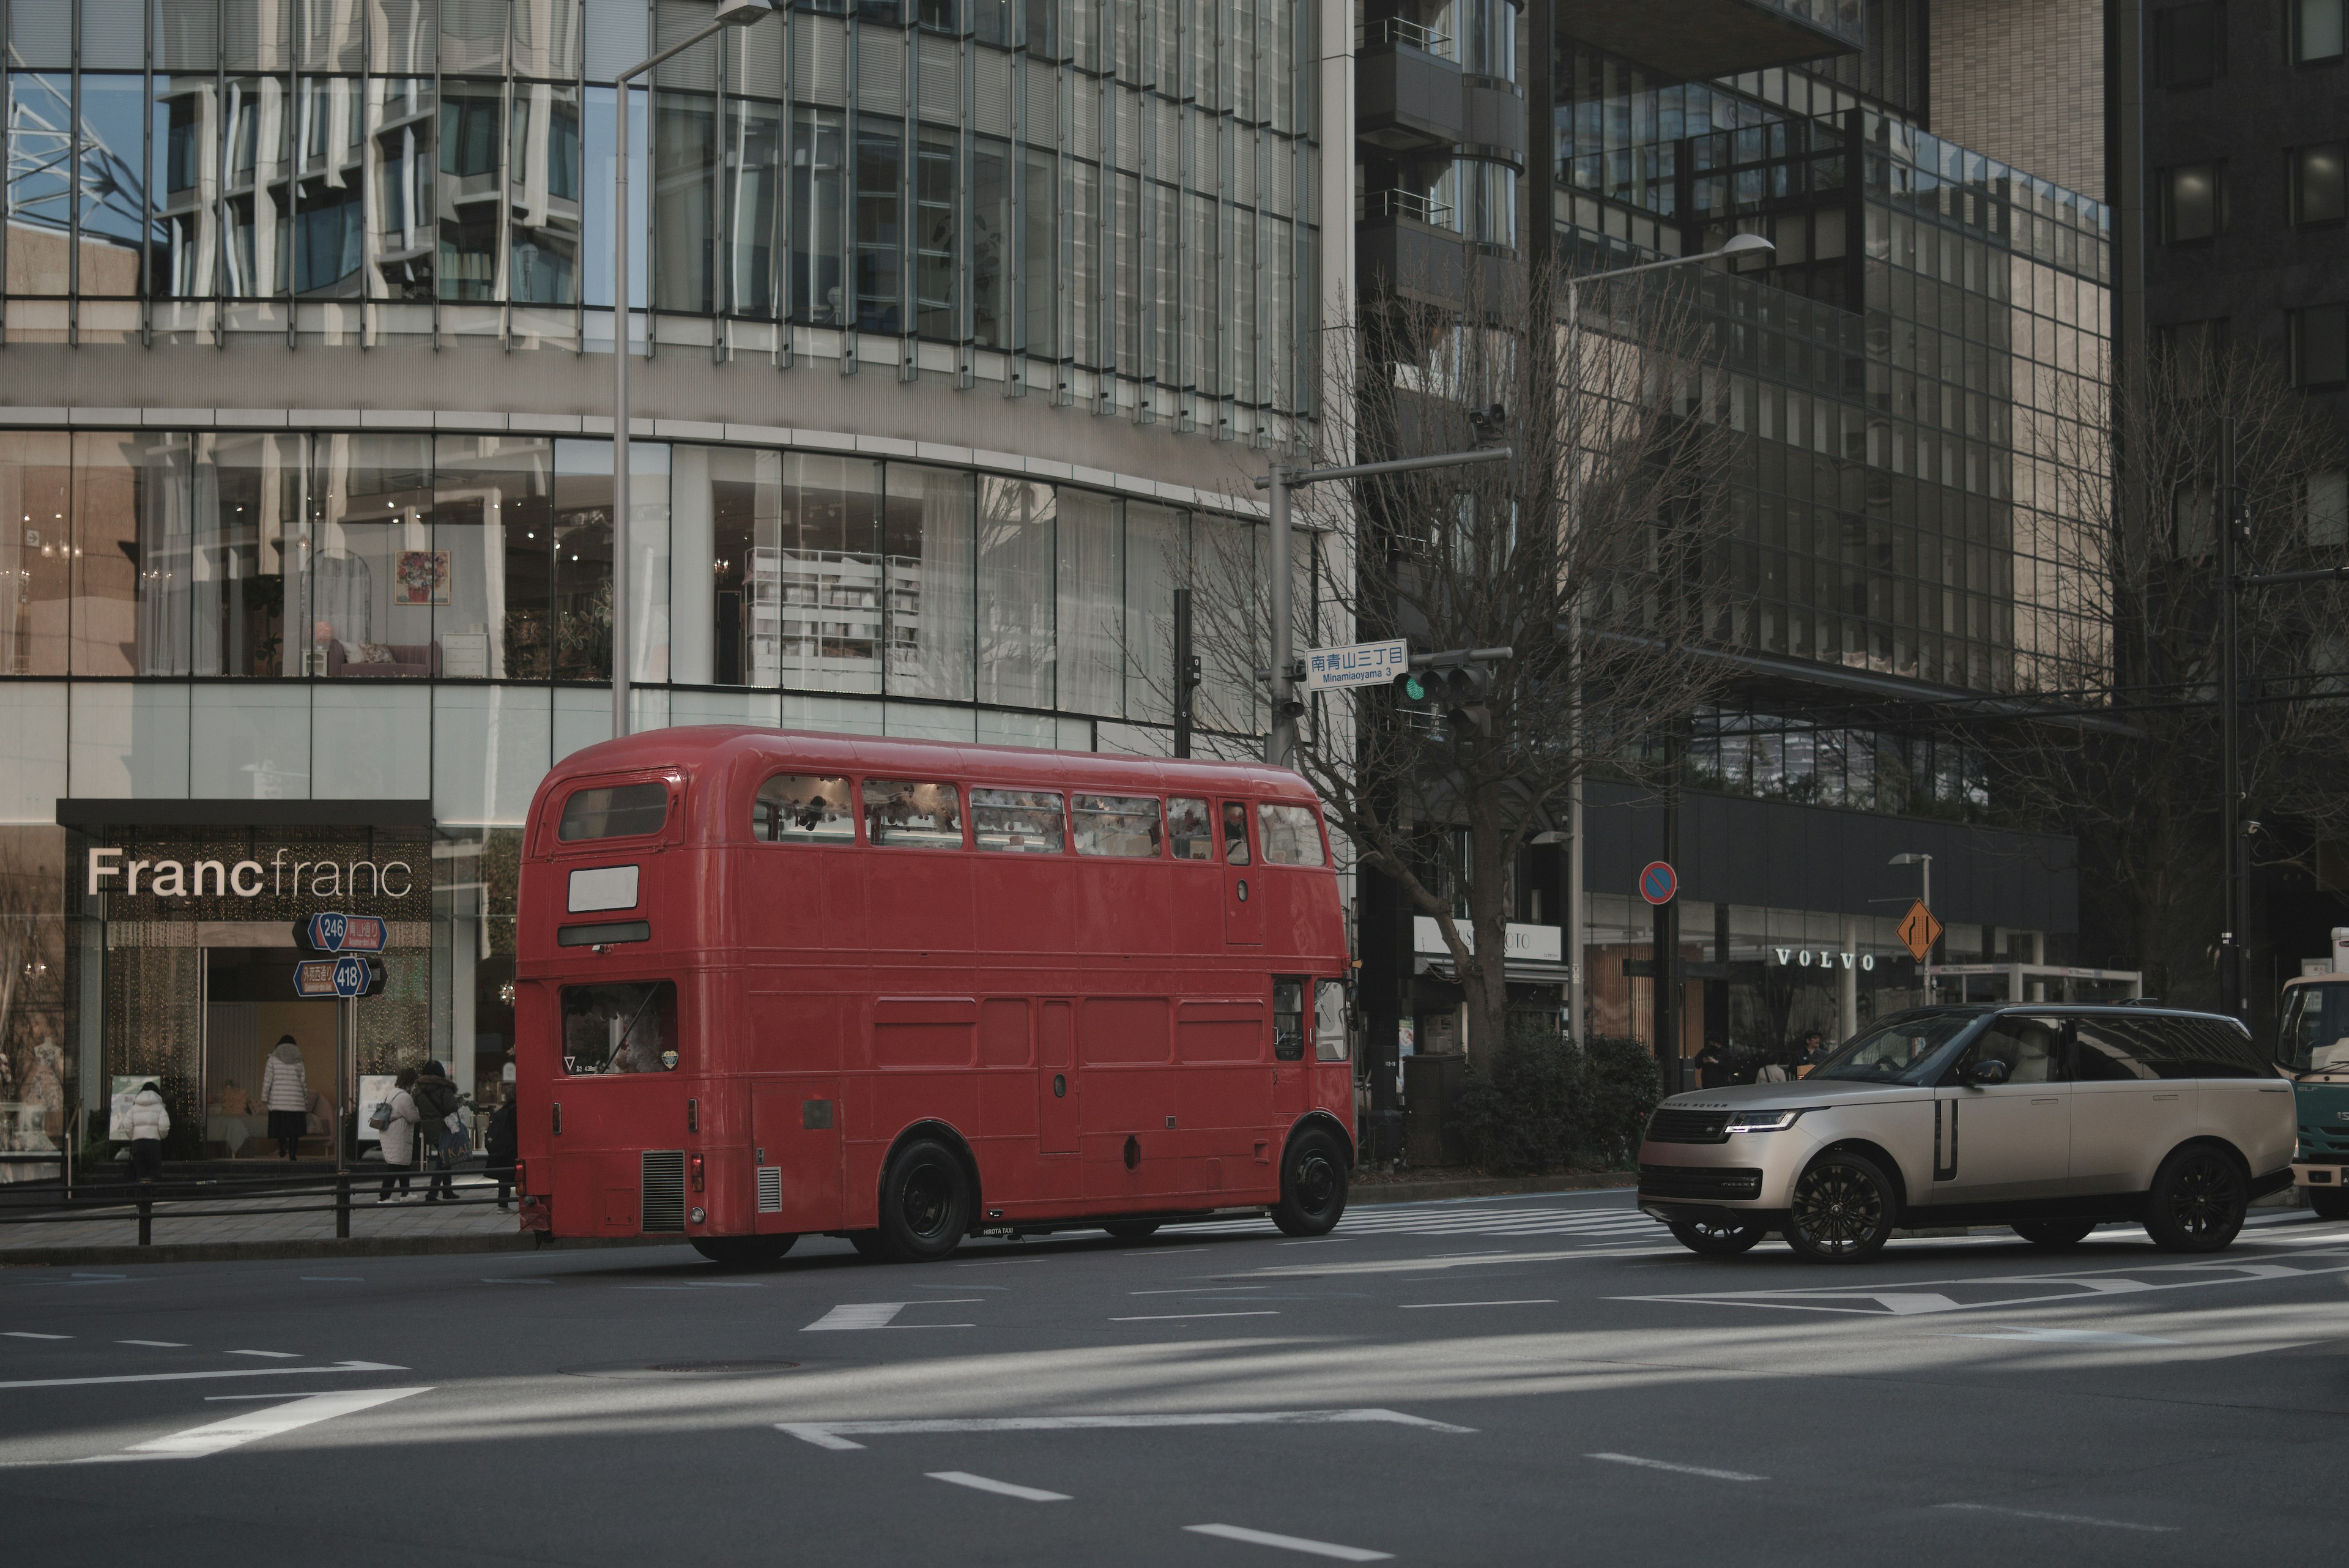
[1997,348,2349,1001]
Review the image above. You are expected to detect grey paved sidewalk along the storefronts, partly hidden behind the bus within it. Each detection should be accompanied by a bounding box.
[0,1169,1637,1267]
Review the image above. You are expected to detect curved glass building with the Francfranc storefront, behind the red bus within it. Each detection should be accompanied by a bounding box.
[0,0,1346,1157]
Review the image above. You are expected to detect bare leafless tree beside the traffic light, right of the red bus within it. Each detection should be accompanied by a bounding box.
[1193,257,1734,1062]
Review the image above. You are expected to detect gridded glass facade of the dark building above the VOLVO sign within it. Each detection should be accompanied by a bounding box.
[1555,42,2112,691]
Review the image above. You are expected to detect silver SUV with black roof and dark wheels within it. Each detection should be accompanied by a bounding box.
[1639,1006,2298,1262]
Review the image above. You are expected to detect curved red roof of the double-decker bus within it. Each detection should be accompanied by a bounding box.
[538,724,1313,799]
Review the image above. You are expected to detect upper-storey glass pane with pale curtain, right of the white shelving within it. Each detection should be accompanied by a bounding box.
[881,463,975,703]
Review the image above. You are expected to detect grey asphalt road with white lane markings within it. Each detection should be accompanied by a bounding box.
[0,1192,2349,1568]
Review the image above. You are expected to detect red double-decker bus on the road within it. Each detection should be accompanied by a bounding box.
[514,726,1353,1262]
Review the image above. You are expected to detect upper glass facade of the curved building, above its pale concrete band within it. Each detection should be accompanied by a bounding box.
[0,0,1324,442]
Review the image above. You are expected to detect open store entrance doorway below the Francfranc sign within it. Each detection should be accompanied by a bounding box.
[204,948,341,1159]
